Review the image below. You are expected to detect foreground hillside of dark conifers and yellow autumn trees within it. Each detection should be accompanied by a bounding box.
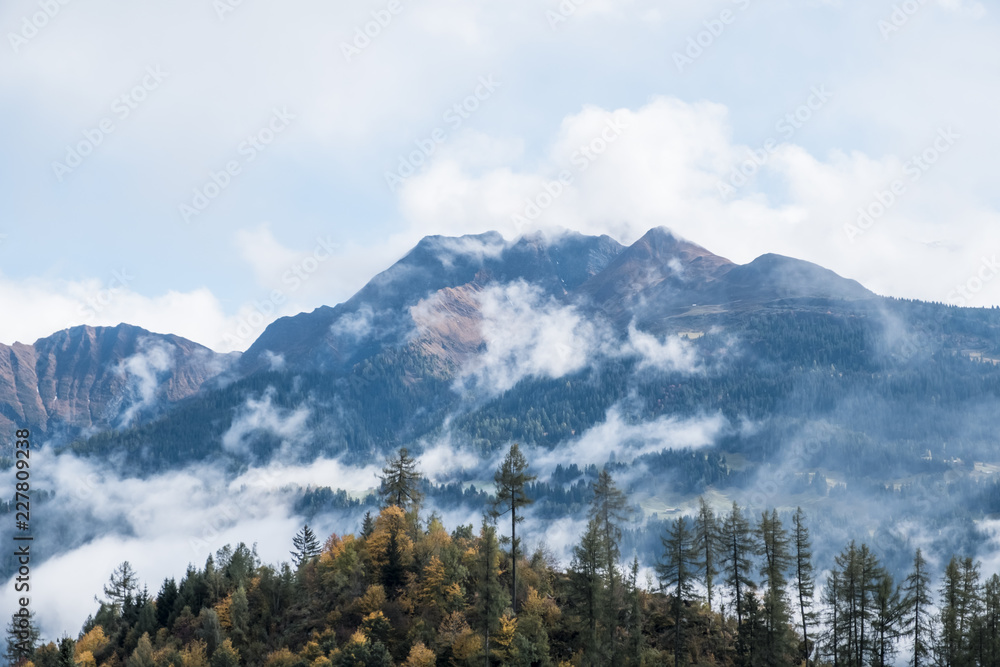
[6,444,1000,667]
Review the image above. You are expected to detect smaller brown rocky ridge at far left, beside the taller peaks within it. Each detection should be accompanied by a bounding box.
[0,324,232,437]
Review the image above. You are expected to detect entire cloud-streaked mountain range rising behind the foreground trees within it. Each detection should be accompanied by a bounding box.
[9,228,1000,596]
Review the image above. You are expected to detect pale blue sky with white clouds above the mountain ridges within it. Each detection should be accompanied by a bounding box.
[0,0,1000,351]
